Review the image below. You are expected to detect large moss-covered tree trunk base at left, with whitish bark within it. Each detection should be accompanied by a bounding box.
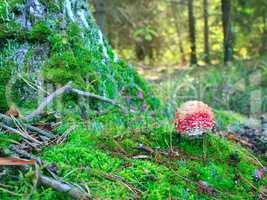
[0,0,154,114]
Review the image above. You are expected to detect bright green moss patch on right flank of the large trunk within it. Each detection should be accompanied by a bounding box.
[40,23,158,111]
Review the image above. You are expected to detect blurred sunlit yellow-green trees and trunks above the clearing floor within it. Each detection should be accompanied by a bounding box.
[92,0,267,65]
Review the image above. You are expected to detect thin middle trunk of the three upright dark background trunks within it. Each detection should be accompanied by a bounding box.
[203,0,210,64]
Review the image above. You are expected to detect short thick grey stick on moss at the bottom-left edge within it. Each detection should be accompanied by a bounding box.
[39,176,92,200]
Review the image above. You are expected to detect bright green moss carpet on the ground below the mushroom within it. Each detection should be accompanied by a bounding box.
[0,113,267,200]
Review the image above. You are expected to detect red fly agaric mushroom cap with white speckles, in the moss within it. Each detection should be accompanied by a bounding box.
[176,101,214,136]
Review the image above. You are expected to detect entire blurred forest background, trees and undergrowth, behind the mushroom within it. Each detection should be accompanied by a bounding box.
[91,0,267,116]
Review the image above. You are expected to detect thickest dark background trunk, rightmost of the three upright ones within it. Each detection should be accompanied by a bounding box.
[222,0,233,64]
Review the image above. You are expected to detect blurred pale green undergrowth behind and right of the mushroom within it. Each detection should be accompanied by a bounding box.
[157,58,267,115]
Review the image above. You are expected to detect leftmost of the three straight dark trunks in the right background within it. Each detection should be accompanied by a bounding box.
[188,0,197,65]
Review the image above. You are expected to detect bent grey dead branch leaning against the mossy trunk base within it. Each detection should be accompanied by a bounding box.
[25,82,127,120]
